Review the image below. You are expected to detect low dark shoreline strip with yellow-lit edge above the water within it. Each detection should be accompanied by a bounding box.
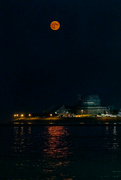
[0,117,121,126]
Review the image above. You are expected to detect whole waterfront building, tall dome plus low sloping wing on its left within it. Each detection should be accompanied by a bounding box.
[44,95,108,117]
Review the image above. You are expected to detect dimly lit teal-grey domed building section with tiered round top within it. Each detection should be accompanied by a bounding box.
[77,95,107,115]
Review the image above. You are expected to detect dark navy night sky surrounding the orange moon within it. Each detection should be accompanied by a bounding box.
[0,0,121,121]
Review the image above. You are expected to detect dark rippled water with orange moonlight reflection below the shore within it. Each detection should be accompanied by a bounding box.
[0,126,121,180]
